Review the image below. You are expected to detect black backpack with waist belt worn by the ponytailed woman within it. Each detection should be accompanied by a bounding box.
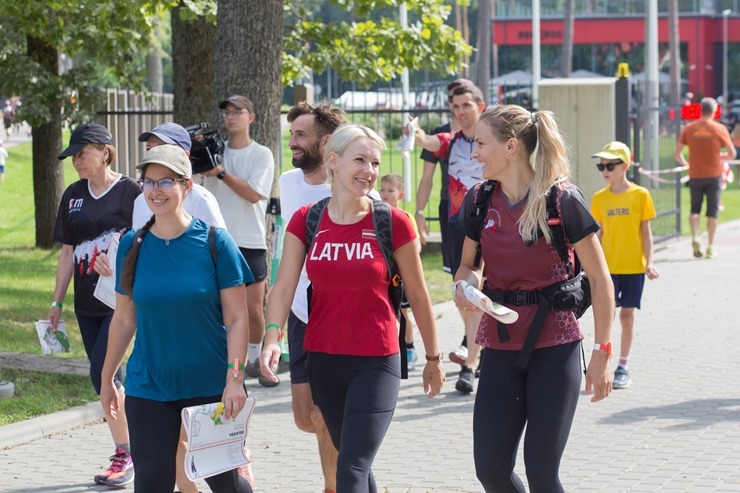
[470,180,591,369]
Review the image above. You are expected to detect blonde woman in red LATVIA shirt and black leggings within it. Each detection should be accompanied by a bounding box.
[261,125,444,493]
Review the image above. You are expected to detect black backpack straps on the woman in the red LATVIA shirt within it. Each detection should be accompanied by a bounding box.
[306,197,408,378]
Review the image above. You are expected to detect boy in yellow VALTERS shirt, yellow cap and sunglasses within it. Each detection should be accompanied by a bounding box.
[591,141,659,389]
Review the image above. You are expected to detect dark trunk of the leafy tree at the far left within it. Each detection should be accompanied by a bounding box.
[26,36,64,248]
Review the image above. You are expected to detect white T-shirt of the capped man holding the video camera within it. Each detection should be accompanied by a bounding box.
[203,141,275,250]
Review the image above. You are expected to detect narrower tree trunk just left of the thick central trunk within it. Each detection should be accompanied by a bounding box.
[171,6,221,126]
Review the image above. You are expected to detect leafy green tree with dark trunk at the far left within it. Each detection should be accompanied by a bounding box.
[0,0,156,248]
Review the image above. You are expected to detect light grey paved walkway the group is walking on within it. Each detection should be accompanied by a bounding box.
[0,222,740,493]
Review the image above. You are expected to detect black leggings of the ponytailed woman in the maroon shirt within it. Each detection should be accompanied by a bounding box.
[473,342,581,493]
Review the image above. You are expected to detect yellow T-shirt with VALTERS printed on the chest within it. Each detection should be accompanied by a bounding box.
[591,183,656,274]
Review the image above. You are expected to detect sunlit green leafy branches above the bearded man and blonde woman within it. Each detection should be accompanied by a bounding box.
[283,0,472,87]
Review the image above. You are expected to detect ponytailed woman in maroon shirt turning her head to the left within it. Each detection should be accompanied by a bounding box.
[454,105,614,493]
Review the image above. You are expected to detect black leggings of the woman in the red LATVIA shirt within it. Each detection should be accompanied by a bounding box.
[307,353,401,493]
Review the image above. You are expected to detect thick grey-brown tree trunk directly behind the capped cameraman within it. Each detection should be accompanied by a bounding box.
[211,0,283,167]
